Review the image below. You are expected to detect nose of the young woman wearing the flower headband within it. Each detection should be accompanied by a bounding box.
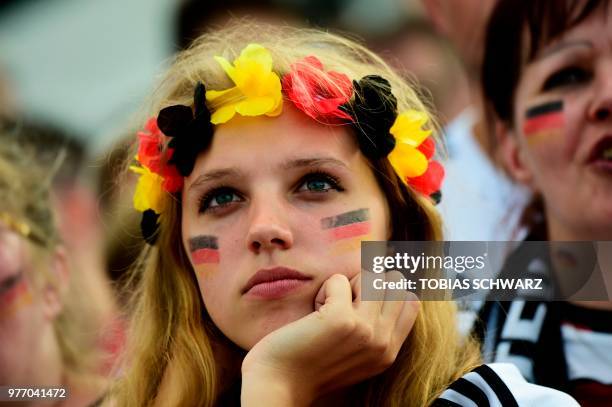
[247,199,293,254]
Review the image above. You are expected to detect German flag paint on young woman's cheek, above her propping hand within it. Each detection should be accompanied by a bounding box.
[321,208,372,254]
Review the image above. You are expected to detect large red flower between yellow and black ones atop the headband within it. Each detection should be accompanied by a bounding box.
[282,56,353,123]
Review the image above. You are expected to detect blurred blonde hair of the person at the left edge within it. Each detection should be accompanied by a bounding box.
[0,134,101,383]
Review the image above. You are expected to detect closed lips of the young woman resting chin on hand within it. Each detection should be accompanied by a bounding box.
[242,267,312,297]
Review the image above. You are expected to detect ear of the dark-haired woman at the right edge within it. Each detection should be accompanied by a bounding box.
[495,120,535,190]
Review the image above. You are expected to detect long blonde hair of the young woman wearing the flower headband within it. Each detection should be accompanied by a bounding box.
[113,22,480,406]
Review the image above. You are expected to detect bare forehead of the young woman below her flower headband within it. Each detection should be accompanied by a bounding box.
[194,102,358,173]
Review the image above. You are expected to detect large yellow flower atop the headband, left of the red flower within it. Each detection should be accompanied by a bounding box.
[206,44,283,124]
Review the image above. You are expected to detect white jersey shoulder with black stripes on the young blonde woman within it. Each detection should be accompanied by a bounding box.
[432,363,579,407]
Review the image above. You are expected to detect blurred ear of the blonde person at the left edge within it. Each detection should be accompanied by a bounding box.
[43,247,70,320]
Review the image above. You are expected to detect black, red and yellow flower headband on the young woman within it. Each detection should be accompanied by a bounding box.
[130,44,444,244]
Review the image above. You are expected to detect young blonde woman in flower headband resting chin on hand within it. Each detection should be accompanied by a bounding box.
[109,24,576,406]
